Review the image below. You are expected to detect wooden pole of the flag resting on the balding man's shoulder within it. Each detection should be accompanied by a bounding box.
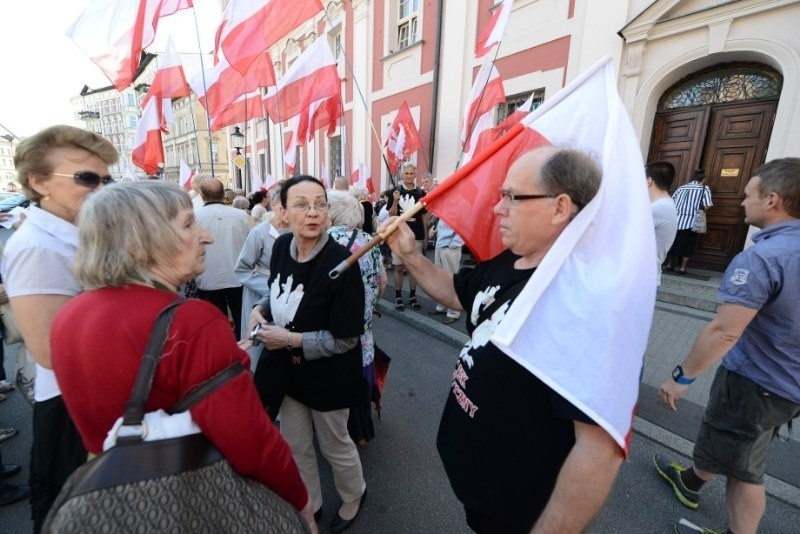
[328,123,526,280]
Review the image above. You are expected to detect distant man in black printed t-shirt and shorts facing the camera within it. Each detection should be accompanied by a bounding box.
[386,161,428,311]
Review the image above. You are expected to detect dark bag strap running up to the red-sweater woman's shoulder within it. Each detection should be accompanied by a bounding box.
[122,298,186,426]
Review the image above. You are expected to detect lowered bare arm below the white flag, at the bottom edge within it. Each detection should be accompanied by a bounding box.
[532,421,623,534]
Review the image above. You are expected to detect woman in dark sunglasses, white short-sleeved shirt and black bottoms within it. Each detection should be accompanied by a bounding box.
[2,126,118,532]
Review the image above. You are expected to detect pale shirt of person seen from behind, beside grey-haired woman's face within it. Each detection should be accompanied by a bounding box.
[194,202,250,291]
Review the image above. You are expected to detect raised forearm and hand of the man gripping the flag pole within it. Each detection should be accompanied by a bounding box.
[386,219,464,310]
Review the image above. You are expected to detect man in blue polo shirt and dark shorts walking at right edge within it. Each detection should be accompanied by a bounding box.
[654,158,800,534]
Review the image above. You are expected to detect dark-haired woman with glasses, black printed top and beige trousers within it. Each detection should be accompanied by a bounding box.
[250,176,366,533]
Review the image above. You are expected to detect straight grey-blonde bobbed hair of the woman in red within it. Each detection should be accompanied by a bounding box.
[73,181,192,288]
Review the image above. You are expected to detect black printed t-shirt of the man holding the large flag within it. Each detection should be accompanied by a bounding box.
[437,251,591,532]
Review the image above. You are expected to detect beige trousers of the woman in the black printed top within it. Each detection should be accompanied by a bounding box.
[280,395,367,511]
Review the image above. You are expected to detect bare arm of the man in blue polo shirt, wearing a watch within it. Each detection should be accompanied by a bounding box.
[659,302,758,412]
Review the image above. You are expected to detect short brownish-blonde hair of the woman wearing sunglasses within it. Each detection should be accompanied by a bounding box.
[14,124,119,202]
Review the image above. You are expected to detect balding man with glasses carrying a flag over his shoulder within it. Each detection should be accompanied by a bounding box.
[388,148,622,532]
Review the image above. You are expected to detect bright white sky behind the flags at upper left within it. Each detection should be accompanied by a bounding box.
[0,0,221,137]
